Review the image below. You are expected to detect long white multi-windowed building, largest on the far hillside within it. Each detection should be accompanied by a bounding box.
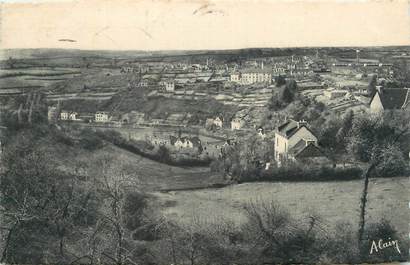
[230,68,272,85]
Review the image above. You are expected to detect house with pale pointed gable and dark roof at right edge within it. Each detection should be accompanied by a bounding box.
[370,87,410,113]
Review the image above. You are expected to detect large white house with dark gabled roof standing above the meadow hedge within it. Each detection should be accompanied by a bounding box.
[275,120,318,163]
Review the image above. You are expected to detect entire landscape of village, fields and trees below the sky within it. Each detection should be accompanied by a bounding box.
[0,47,410,265]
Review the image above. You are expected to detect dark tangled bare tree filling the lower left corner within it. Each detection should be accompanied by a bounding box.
[0,129,99,263]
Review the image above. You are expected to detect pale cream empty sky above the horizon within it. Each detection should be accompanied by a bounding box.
[0,0,410,50]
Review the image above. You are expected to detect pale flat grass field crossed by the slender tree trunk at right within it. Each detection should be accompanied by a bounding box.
[155,177,410,236]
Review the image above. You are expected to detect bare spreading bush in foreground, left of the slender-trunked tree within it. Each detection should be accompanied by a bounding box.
[243,201,326,264]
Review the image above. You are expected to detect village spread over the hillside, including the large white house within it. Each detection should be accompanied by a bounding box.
[36,47,410,168]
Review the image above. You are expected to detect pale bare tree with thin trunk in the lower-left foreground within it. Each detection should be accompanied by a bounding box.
[92,156,147,265]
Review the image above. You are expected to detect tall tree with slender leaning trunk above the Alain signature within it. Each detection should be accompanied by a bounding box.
[347,111,410,245]
